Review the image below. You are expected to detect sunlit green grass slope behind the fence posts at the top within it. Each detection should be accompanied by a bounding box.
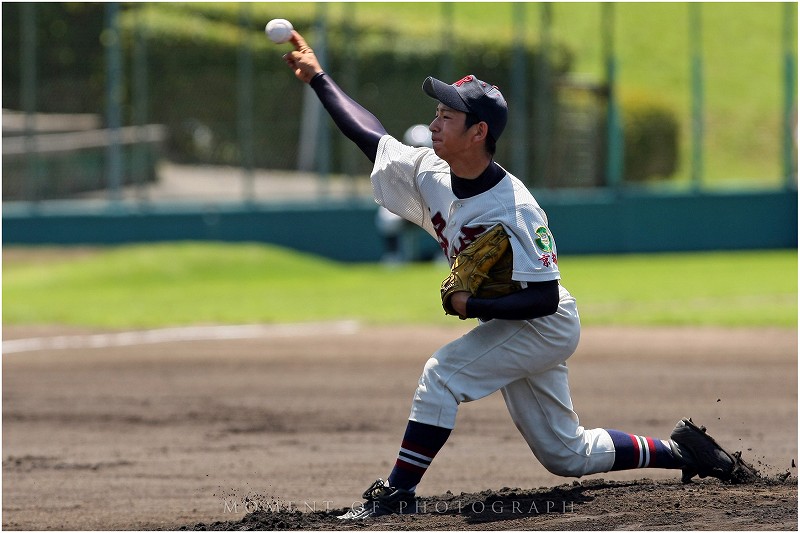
[188,2,797,187]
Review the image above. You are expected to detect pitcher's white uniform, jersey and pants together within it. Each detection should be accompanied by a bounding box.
[371,135,614,476]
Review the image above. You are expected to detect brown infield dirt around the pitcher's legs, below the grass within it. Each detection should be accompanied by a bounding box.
[2,324,798,530]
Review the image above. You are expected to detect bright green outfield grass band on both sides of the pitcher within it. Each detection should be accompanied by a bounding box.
[3,243,797,328]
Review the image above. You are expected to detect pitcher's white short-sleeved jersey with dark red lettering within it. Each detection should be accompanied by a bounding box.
[370,135,561,282]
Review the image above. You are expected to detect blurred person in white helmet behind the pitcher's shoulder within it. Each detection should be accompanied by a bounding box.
[375,124,433,265]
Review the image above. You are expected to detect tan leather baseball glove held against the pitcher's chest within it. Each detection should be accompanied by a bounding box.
[441,224,520,319]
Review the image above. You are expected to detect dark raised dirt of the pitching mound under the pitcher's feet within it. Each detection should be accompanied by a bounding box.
[180,475,797,531]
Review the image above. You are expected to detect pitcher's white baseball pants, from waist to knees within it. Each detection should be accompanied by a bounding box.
[409,287,614,477]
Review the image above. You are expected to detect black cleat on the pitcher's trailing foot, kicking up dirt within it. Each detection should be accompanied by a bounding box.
[670,418,758,483]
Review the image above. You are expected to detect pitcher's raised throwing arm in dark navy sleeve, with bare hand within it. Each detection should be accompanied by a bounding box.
[283,31,386,163]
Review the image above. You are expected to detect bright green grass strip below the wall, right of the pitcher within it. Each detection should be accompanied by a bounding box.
[560,251,797,327]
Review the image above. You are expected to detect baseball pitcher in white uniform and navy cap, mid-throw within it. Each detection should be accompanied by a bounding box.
[284,31,752,520]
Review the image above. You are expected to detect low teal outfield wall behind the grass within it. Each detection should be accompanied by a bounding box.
[3,191,798,261]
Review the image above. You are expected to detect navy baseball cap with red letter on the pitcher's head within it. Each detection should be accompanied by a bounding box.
[422,74,508,141]
